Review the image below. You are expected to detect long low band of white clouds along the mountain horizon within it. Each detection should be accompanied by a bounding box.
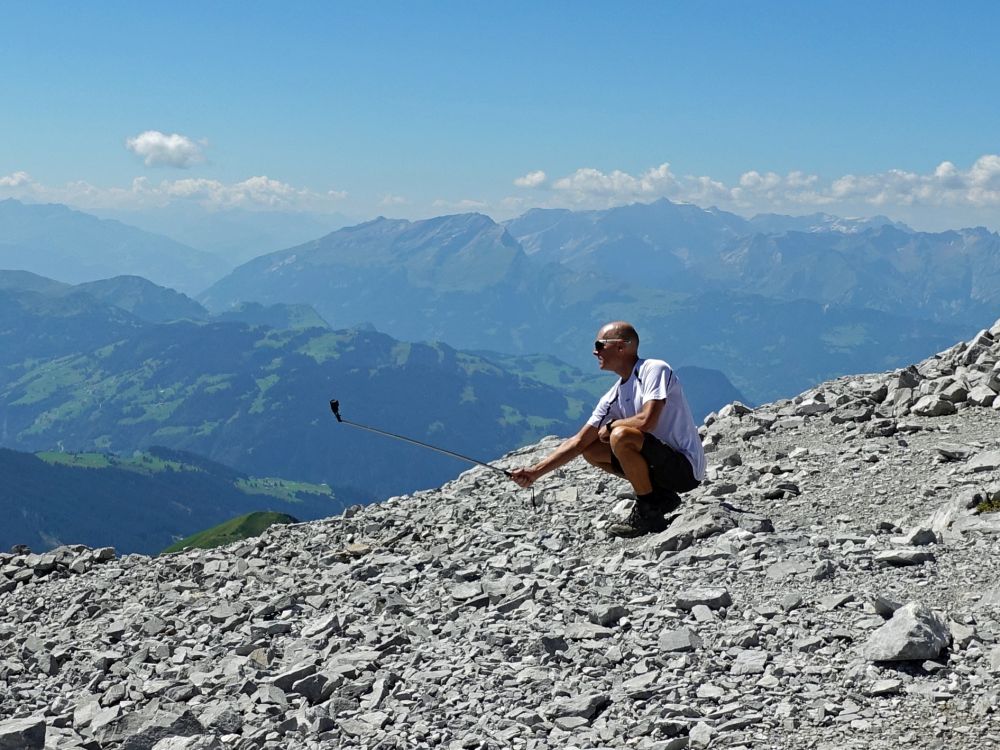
[0,154,1000,231]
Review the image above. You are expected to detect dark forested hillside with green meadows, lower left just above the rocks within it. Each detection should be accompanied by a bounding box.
[0,447,345,554]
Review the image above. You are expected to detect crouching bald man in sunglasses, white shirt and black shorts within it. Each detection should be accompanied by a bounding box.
[511,321,705,537]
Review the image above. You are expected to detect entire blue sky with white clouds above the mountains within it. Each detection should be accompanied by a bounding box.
[0,2,1000,229]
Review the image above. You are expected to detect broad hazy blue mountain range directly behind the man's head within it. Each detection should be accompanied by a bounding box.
[199,200,980,402]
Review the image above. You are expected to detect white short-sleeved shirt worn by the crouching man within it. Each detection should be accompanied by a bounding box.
[587,359,705,482]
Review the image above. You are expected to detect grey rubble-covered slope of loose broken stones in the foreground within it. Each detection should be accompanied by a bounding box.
[0,324,1000,750]
